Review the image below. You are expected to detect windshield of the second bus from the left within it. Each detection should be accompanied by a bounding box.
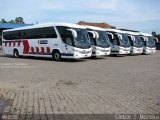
[96,31,111,48]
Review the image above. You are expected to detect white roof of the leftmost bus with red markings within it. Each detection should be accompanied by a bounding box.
[3,23,86,32]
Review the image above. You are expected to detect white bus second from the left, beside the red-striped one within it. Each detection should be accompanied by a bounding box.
[84,26,111,57]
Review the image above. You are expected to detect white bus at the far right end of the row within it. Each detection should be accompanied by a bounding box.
[139,33,158,54]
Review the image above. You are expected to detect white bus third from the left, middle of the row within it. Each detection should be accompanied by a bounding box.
[105,29,130,55]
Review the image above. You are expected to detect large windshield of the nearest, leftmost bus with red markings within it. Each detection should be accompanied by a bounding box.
[73,28,91,49]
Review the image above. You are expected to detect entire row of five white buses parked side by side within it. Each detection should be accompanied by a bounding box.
[2,23,157,60]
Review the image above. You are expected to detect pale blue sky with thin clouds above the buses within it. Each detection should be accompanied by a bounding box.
[0,0,160,33]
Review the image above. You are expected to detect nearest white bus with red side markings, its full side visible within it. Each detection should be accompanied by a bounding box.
[2,23,92,60]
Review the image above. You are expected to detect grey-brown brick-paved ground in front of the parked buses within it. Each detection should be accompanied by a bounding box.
[0,51,160,119]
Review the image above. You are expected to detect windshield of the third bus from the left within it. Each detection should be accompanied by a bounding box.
[119,33,130,47]
